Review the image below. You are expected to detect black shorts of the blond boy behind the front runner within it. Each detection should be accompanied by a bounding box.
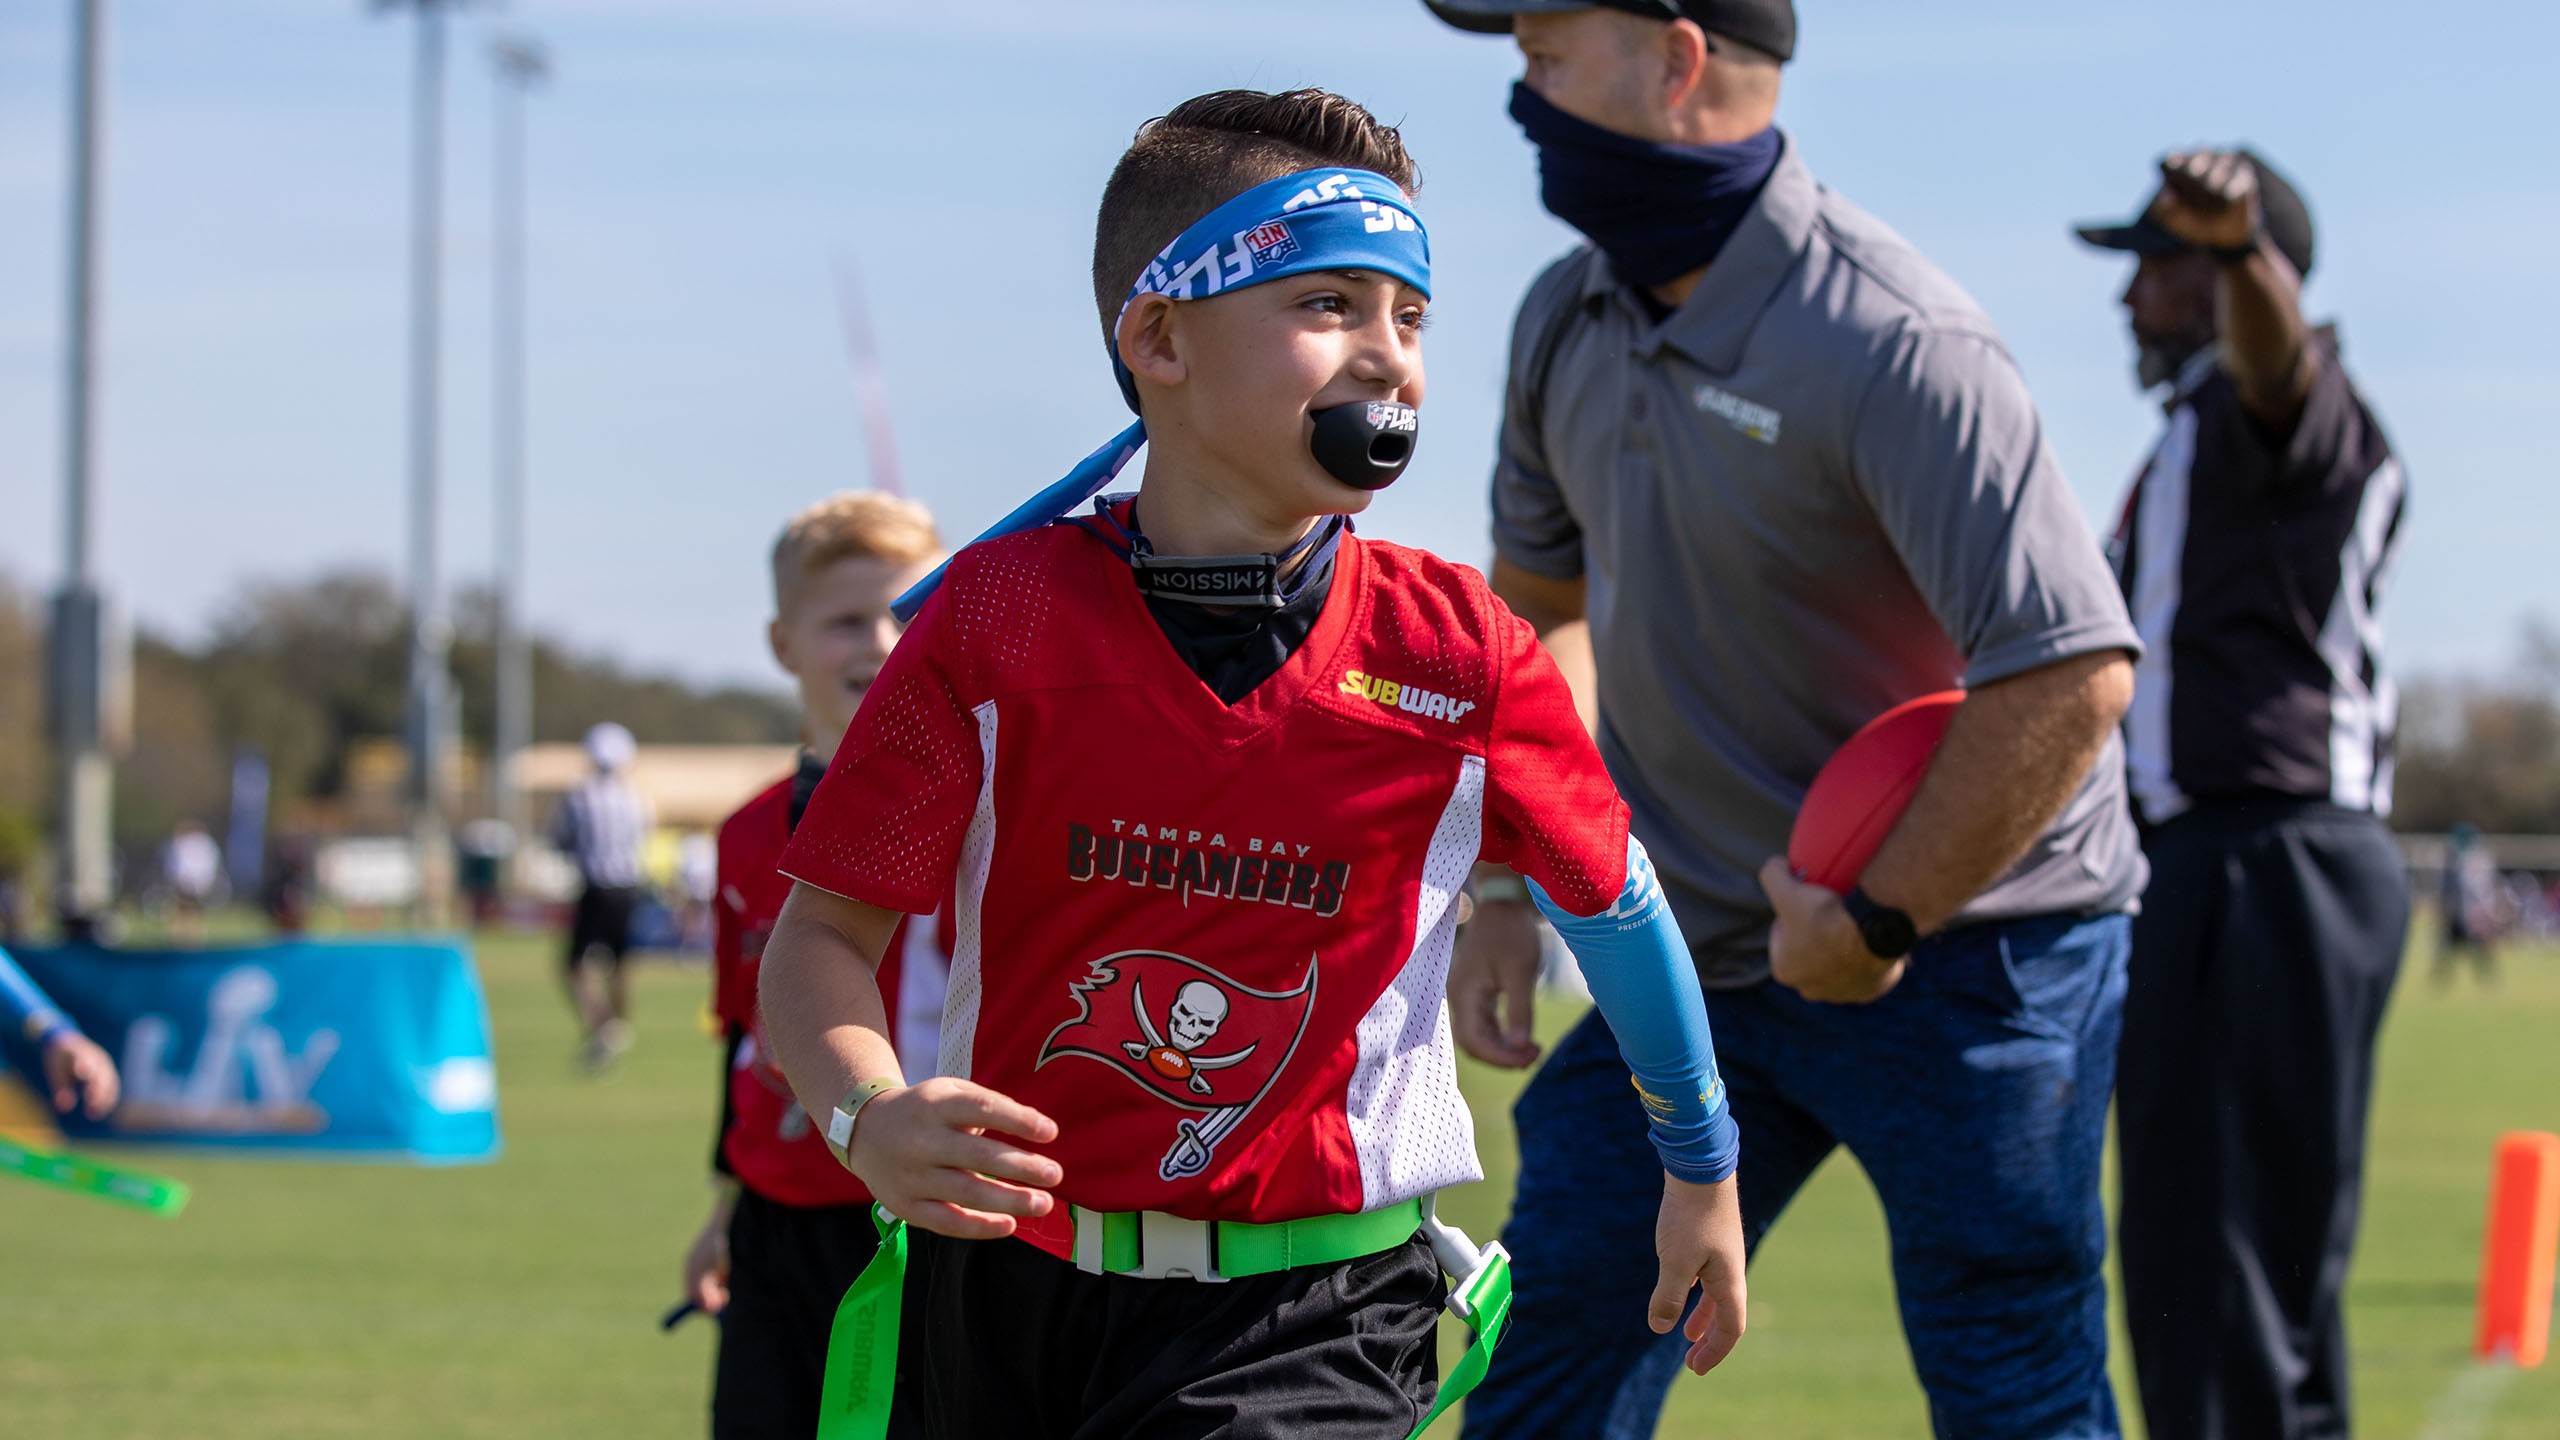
[712,1189,924,1440]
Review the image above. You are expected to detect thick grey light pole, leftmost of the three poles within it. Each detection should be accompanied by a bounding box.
[46,0,115,935]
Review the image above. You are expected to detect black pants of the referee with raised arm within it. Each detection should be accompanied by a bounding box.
[2117,799,2409,1440]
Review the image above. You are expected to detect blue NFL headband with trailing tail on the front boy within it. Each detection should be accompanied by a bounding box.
[888,169,1431,620]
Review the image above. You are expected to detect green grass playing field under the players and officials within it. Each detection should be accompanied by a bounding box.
[0,917,2560,1440]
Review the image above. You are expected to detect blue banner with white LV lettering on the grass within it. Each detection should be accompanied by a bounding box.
[0,940,499,1163]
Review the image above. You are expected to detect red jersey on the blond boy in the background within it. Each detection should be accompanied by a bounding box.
[712,776,950,1204]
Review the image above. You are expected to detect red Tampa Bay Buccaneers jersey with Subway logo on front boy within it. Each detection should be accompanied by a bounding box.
[783,525,1628,1220]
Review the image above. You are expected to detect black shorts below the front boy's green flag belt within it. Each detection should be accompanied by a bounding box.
[899,1227,1446,1440]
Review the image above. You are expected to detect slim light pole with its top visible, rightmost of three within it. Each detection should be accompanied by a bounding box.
[489,36,550,840]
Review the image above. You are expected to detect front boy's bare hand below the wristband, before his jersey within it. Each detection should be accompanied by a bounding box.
[847,1079,1065,1240]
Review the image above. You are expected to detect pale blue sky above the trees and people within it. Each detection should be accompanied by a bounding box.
[0,0,2560,682]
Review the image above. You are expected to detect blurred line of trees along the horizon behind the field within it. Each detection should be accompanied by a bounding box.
[0,569,2560,876]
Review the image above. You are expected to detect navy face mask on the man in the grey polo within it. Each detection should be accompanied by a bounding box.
[1510,85,1779,284]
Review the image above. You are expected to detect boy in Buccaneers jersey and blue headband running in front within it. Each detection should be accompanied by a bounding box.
[763,90,1743,1440]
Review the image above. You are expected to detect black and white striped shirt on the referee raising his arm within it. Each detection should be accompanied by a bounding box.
[2112,331,2406,825]
